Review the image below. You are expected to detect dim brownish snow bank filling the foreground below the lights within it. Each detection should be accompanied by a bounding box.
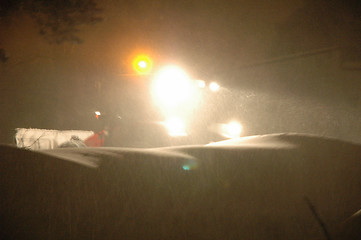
[0,134,361,240]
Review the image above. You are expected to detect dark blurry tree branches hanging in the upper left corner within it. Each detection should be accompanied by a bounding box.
[0,0,102,44]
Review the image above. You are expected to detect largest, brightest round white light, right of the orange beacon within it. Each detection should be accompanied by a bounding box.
[152,66,195,107]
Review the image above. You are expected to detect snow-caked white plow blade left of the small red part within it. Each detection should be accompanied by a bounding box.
[15,128,94,150]
